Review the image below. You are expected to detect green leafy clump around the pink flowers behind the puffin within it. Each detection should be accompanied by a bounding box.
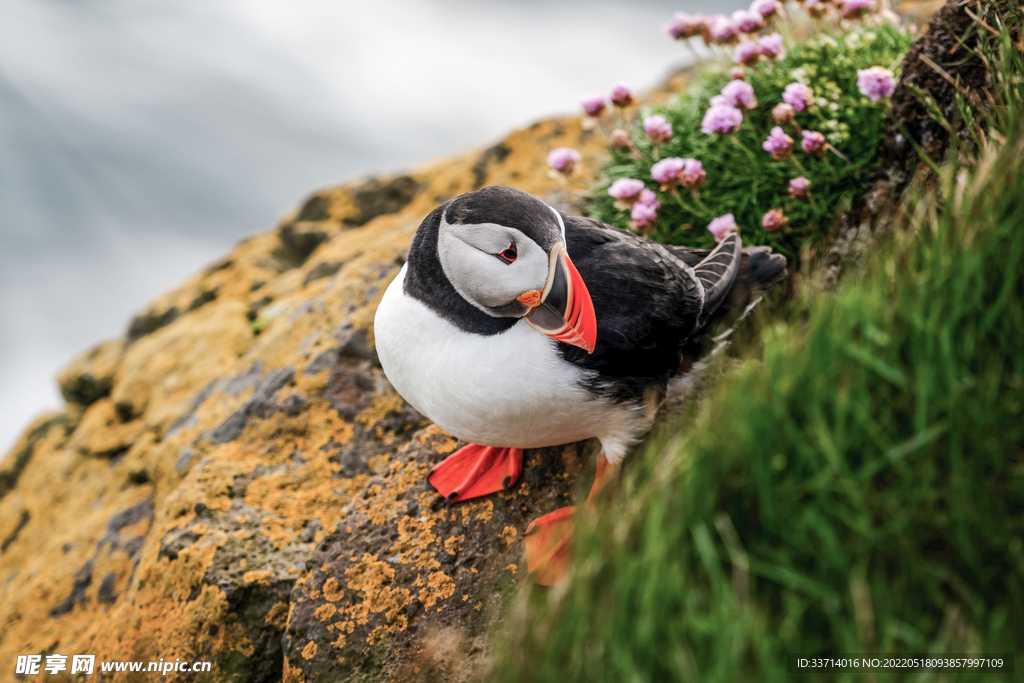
[588,20,911,261]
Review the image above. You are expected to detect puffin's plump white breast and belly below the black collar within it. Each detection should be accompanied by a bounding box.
[374,268,643,459]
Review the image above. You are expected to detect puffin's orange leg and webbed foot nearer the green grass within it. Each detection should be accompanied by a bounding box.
[524,452,618,586]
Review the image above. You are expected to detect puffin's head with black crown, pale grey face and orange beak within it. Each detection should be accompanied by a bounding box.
[437,186,597,352]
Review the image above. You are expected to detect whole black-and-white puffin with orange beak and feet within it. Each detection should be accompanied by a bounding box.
[374,186,786,586]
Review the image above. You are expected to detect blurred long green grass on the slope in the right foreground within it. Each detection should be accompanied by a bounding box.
[494,3,1024,683]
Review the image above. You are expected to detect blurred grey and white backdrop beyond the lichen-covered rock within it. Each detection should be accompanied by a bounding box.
[0,0,749,458]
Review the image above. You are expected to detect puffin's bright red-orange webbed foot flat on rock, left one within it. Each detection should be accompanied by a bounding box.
[427,443,522,503]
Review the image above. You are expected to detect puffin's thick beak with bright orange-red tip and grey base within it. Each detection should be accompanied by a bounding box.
[526,245,597,353]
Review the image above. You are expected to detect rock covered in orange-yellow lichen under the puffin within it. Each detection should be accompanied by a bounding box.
[0,109,603,681]
